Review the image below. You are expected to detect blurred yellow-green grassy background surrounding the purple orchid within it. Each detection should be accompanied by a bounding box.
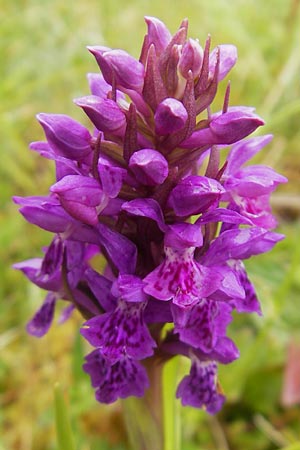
[0,0,300,450]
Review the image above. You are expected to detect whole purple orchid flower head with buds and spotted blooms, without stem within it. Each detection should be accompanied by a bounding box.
[14,17,286,413]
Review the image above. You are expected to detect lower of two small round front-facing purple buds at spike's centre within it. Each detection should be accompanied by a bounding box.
[129,148,168,186]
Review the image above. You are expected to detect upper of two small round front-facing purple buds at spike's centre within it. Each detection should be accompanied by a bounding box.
[154,98,188,136]
